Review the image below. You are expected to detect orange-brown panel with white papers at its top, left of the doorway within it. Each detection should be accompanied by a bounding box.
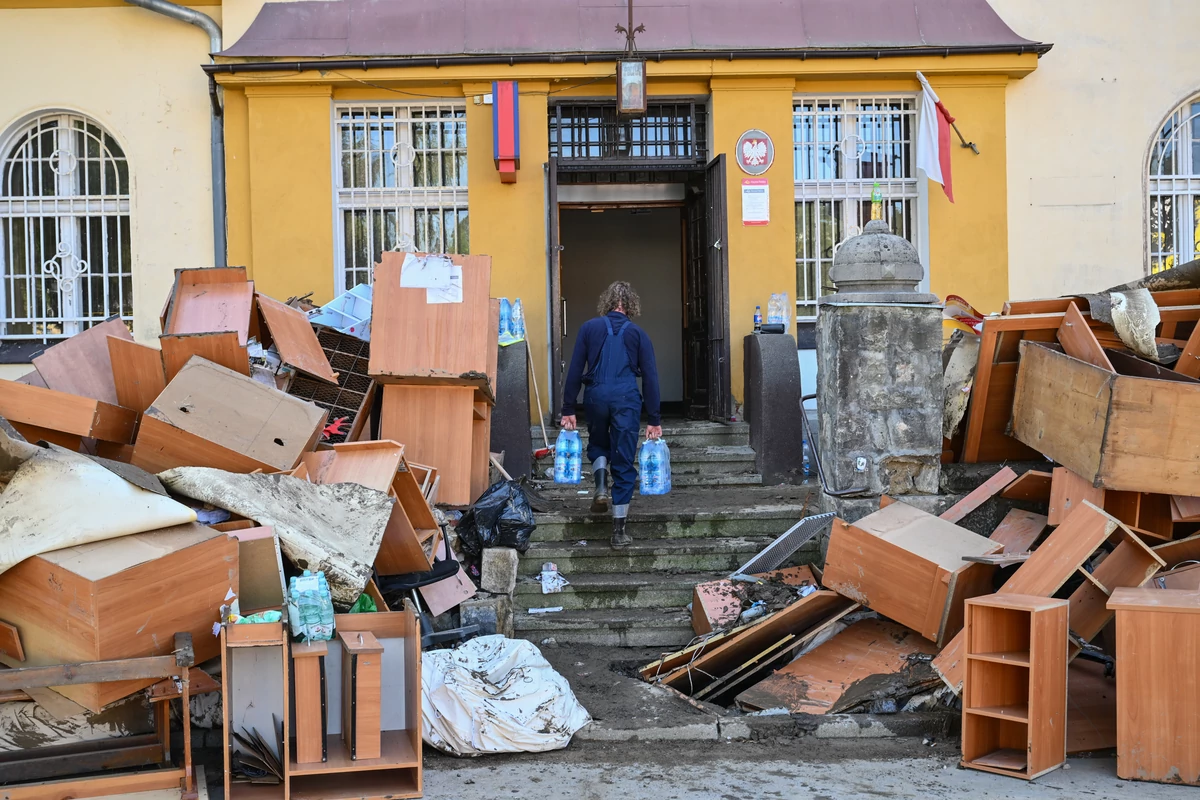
[371,252,496,388]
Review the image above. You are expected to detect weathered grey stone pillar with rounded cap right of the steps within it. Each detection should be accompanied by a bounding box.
[816,221,943,507]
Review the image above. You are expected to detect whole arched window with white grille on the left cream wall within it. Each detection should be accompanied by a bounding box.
[0,112,133,341]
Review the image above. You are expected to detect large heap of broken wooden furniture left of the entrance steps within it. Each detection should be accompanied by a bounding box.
[0,254,498,799]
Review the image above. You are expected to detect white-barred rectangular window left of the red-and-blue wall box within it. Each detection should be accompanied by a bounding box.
[334,103,470,289]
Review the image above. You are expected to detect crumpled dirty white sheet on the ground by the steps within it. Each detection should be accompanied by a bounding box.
[421,636,592,756]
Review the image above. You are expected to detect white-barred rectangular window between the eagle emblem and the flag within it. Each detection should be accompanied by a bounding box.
[792,96,920,320]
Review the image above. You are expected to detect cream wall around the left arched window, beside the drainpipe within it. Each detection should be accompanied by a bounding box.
[0,6,221,345]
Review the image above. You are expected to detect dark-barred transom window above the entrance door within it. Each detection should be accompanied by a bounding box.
[550,100,708,169]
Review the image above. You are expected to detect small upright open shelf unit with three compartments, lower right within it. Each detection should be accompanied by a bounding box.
[962,594,1068,780]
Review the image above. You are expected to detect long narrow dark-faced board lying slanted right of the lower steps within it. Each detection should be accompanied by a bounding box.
[660,591,858,694]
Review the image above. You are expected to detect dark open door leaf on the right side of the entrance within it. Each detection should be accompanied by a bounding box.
[697,154,733,422]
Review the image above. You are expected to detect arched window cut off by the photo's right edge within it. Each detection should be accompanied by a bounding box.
[1147,95,1200,272]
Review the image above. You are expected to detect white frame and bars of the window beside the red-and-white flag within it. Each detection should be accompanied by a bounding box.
[792,92,929,323]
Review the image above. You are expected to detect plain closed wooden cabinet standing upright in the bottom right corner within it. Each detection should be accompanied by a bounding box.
[1109,589,1200,786]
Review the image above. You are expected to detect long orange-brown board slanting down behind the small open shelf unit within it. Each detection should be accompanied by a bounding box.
[934,500,1121,691]
